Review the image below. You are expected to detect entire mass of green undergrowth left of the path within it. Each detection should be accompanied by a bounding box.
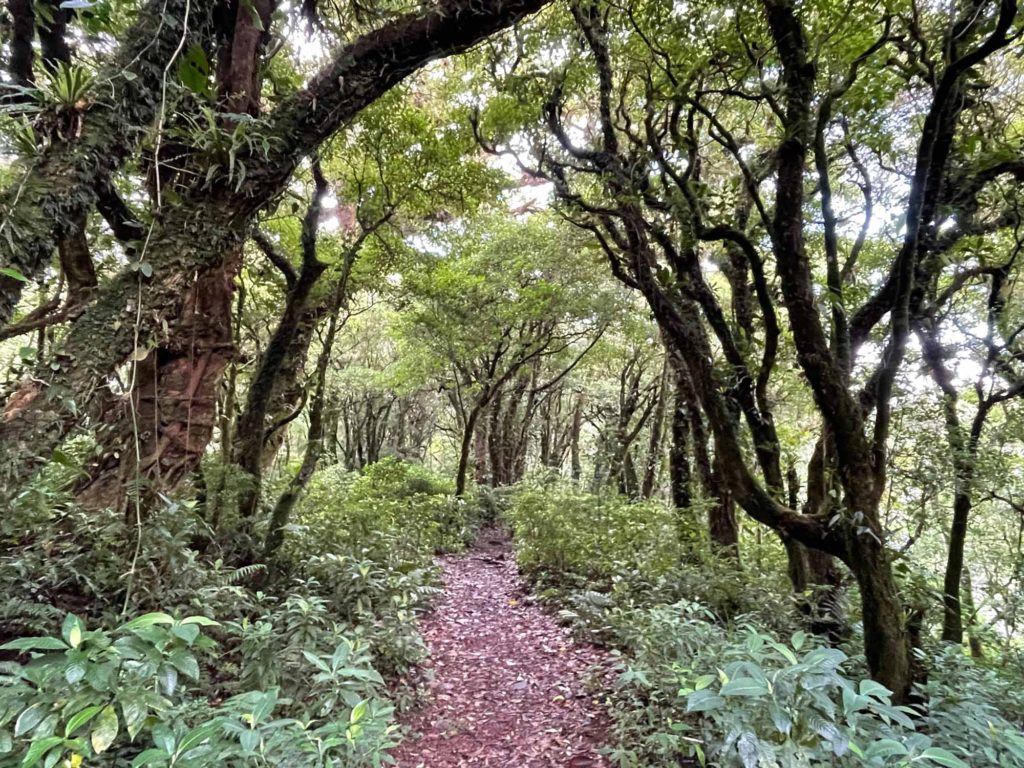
[0,457,482,768]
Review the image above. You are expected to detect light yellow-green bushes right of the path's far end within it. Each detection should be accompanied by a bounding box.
[505,484,786,626]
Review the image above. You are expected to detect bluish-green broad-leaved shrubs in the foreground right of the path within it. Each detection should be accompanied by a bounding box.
[598,622,1024,768]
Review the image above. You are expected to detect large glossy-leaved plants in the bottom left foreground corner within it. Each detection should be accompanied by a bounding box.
[0,612,396,768]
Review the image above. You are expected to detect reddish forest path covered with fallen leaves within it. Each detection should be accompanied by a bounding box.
[392,529,610,768]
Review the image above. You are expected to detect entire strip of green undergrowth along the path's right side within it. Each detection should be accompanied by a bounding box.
[505,484,1024,768]
